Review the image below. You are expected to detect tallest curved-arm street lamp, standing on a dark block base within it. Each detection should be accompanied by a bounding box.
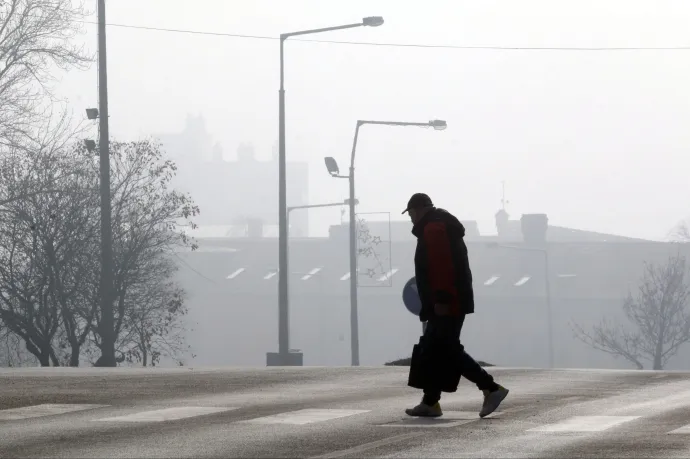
[272,18,383,365]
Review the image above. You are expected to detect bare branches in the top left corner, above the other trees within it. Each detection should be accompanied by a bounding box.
[0,0,92,142]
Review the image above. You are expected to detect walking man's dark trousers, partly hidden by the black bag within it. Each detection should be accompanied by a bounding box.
[423,314,498,405]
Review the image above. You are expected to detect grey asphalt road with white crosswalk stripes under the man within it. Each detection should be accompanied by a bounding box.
[0,367,690,458]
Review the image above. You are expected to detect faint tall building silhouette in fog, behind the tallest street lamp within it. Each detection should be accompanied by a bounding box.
[158,115,309,238]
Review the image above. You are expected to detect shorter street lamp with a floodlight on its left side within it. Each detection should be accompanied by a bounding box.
[325,120,448,367]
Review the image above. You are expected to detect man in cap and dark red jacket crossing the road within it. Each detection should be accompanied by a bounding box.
[403,193,508,418]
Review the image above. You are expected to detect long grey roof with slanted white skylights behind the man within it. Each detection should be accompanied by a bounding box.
[179,238,690,299]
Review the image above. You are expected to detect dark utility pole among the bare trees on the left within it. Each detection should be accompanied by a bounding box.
[96,0,117,367]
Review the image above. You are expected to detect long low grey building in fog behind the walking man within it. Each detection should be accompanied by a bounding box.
[173,215,690,369]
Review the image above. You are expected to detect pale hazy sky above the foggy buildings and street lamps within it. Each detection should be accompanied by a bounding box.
[56,0,690,238]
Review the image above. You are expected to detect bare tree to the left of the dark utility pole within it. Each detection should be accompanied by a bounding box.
[0,113,98,366]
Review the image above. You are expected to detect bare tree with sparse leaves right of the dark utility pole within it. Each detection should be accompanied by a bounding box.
[87,140,199,362]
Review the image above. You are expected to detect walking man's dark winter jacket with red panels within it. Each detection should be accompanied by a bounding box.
[412,208,474,322]
